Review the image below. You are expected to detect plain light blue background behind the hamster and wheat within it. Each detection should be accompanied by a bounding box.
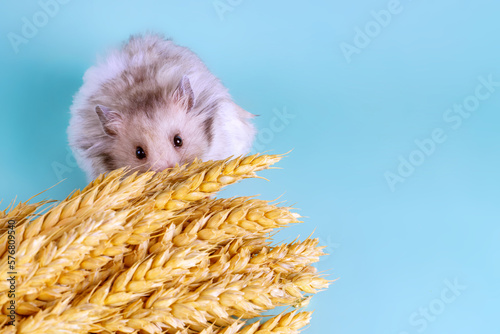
[0,0,500,334]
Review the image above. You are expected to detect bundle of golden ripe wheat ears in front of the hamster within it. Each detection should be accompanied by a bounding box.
[0,155,330,334]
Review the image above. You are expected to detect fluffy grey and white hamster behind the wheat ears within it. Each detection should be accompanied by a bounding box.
[67,34,255,181]
